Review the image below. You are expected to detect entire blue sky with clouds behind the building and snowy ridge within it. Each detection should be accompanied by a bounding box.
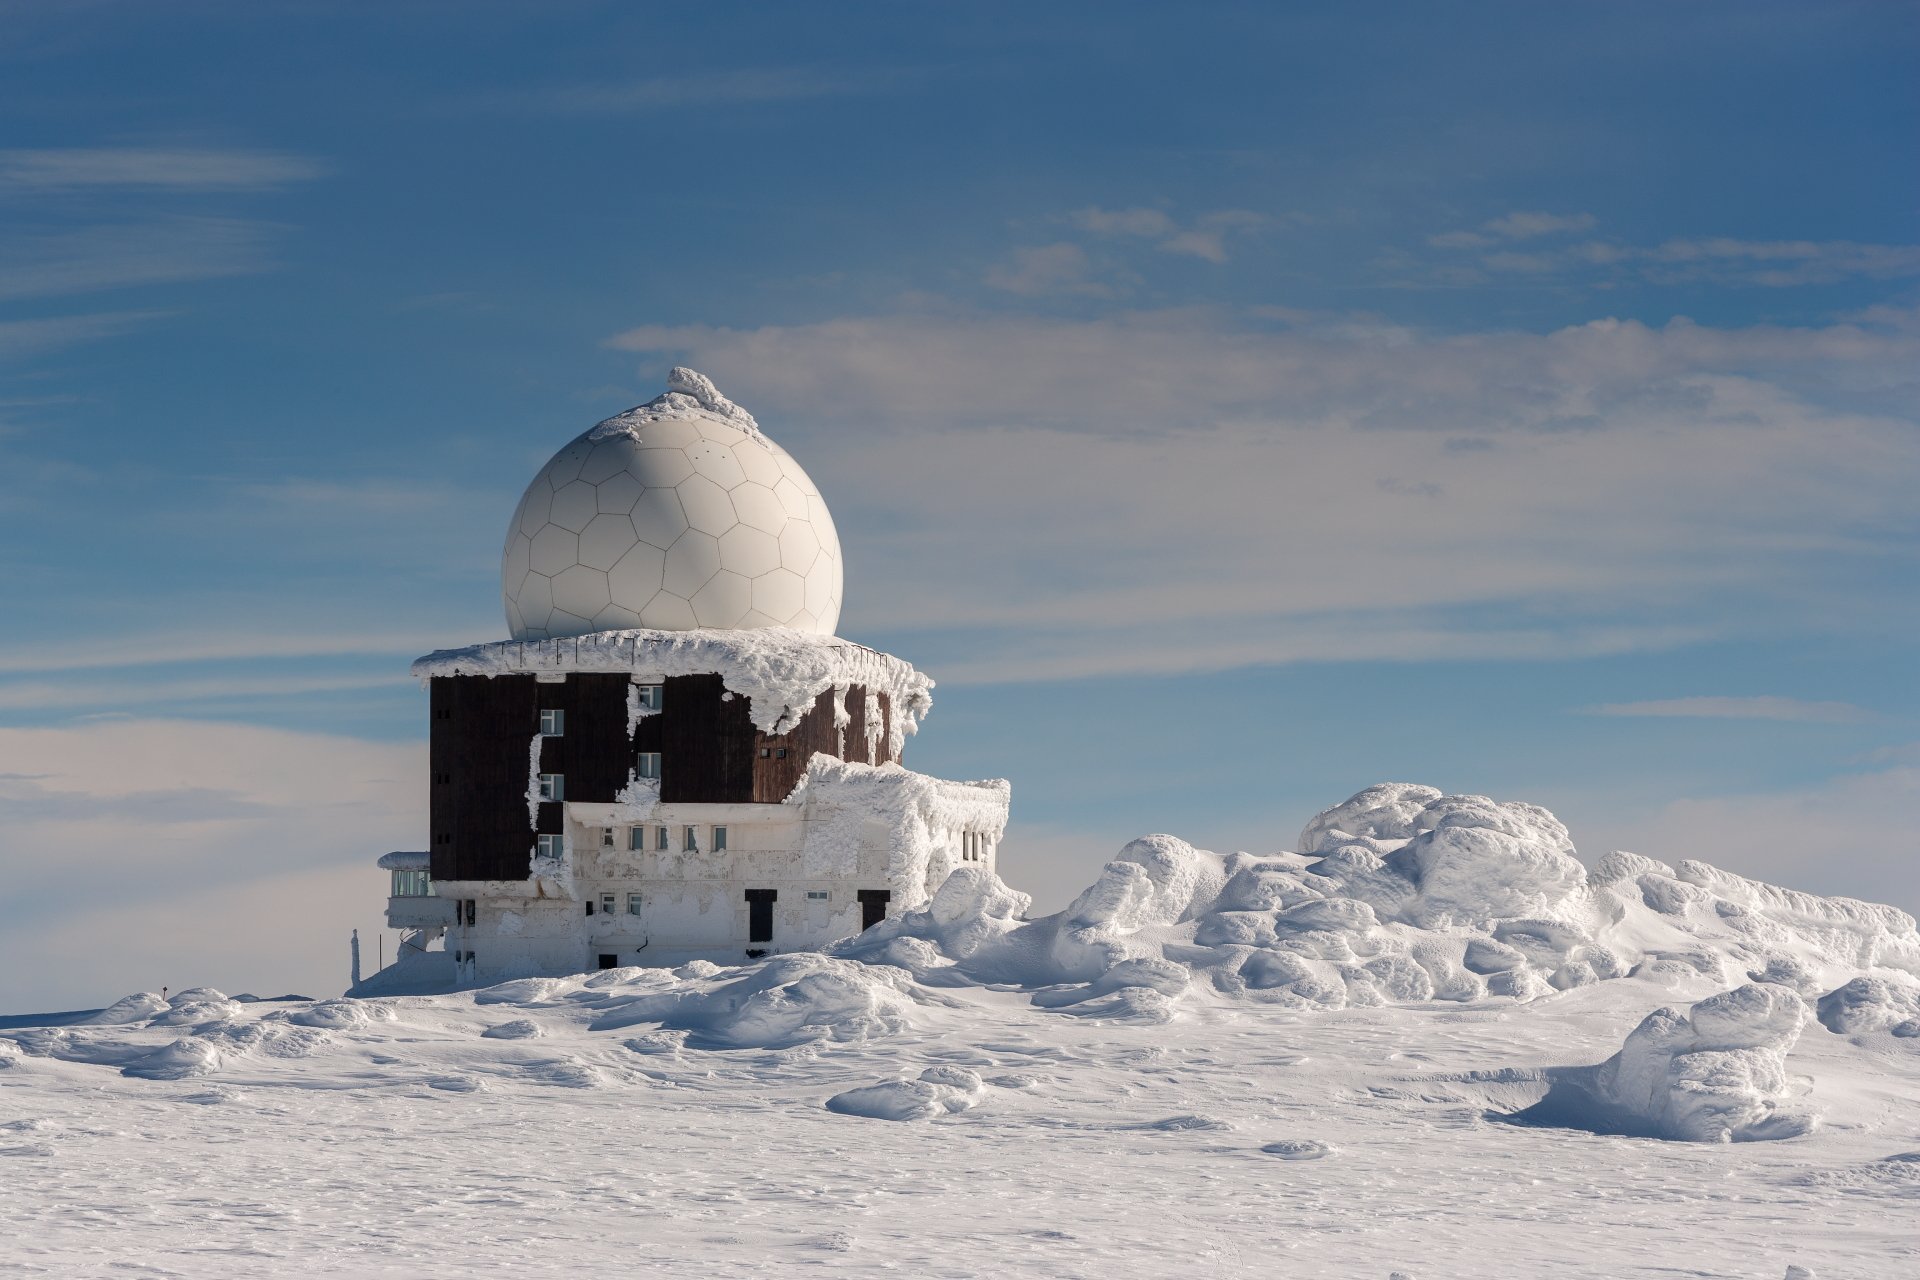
[0,0,1920,1007]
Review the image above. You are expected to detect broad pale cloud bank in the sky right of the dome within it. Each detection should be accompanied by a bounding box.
[612,311,1920,679]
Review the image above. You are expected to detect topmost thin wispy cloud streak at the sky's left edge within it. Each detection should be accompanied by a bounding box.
[0,146,328,192]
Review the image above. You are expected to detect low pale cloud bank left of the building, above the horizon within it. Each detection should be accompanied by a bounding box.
[0,720,426,1011]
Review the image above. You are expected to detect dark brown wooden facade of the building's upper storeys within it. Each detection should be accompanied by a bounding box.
[428,672,895,881]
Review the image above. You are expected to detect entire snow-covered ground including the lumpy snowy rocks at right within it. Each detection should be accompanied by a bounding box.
[0,785,1920,1280]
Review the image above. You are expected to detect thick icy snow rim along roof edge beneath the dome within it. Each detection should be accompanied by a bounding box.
[413,628,933,740]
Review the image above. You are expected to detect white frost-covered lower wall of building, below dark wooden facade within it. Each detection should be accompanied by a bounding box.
[405,754,1010,992]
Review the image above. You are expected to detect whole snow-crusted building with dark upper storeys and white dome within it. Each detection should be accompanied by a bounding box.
[357,368,1008,994]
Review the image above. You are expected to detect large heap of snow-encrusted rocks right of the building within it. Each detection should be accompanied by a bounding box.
[835,783,1920,1059]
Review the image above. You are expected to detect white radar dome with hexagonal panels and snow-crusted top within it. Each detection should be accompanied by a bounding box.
[499,368,841,639]
